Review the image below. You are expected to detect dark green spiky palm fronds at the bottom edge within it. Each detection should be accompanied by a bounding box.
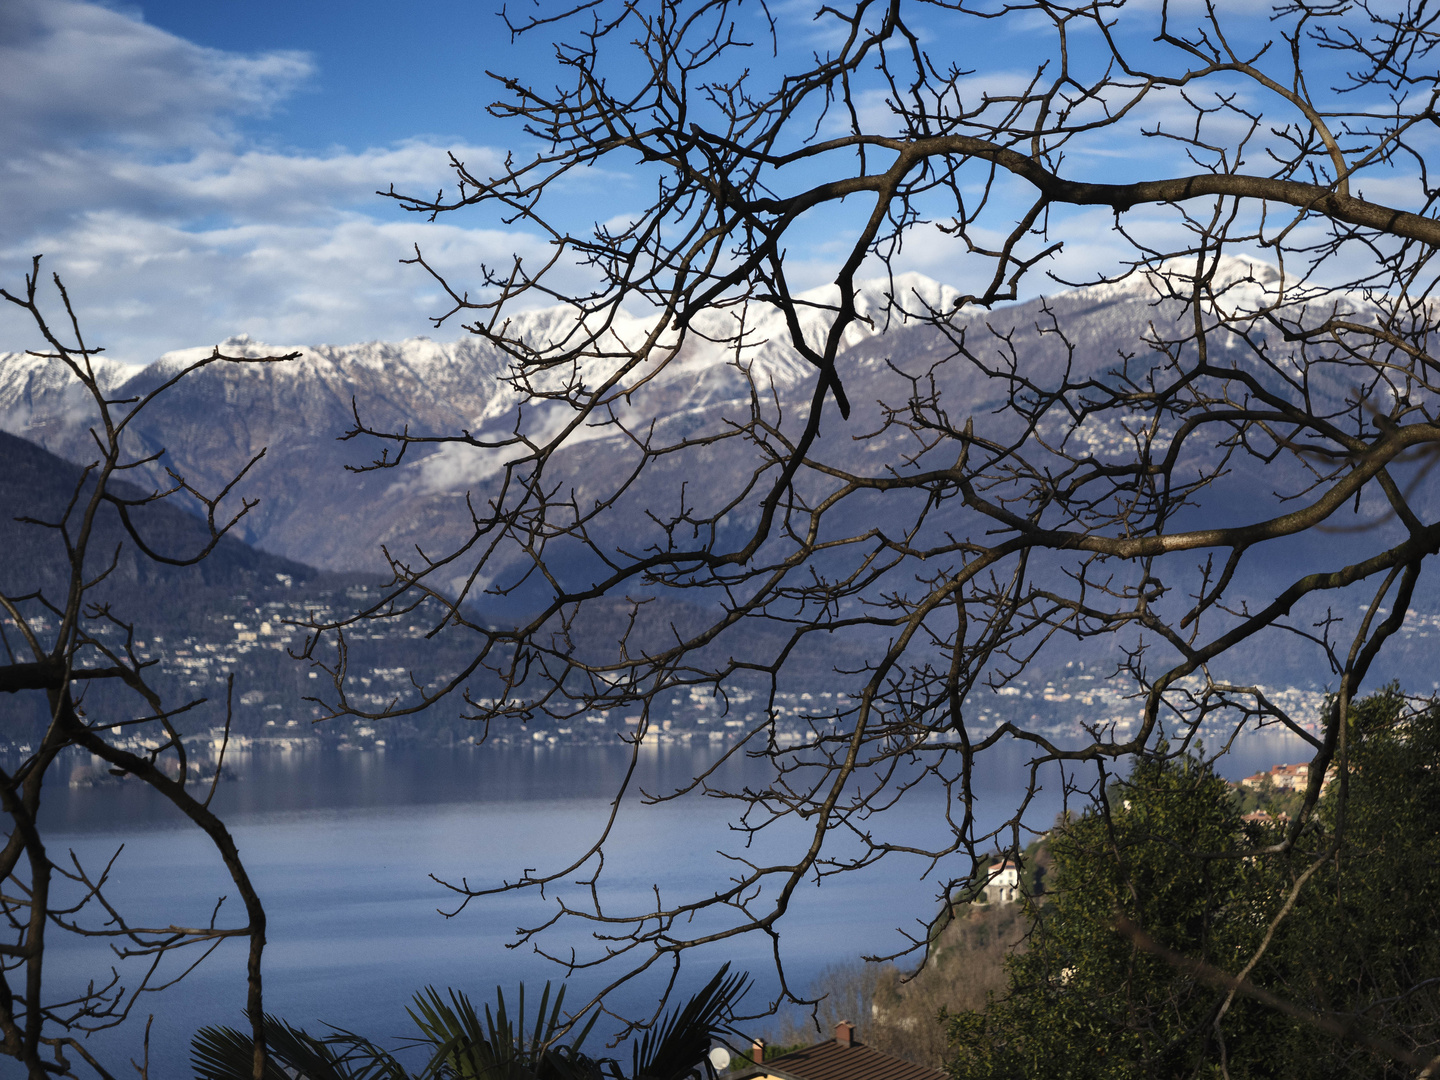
[192,965,747,1080]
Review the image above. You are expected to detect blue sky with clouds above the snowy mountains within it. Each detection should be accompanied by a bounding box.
[0,0,1382,363]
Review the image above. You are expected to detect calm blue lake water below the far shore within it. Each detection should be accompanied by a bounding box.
[36,734,1309,1079]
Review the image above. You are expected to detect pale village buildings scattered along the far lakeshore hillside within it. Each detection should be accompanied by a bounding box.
[0,529,1325,753]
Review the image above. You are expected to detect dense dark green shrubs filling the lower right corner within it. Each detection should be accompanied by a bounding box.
[948,690,1440,1080]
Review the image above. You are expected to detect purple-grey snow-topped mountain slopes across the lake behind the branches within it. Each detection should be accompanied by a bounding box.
[0,259,1431,696]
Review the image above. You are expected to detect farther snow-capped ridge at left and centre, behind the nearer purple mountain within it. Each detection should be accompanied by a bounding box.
[0,275,973,569]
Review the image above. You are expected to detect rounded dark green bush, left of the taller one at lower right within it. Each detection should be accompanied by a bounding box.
[952,759,1256,1077]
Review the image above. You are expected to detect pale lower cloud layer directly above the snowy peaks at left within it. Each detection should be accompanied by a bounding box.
[0,212,579,363]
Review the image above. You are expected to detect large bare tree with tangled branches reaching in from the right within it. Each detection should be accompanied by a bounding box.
[300,0,1440,1059]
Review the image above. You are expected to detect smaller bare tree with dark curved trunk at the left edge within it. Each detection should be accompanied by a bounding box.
[0,258,292,1080]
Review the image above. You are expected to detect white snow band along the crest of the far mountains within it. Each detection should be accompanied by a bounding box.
[0,274,1105,449]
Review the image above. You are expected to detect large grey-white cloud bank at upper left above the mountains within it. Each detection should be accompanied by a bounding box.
[0,0,543,363]
